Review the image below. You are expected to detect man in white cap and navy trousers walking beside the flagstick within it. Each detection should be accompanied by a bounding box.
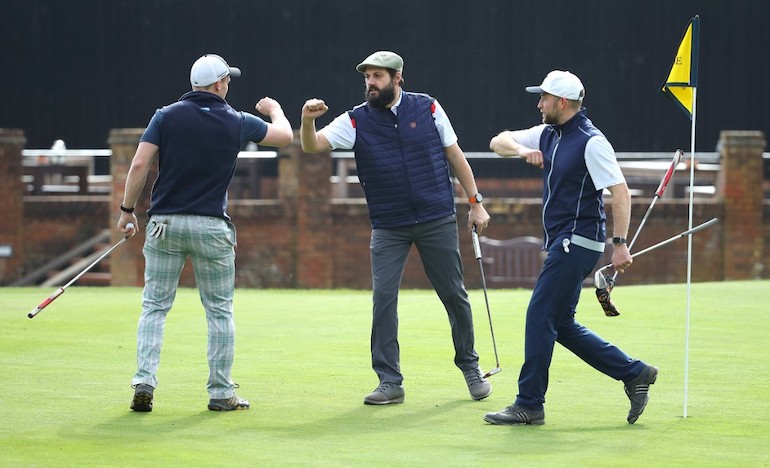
[484,70,658,425]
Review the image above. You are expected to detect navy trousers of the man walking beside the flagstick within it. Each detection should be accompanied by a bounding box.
[516,239,645,411]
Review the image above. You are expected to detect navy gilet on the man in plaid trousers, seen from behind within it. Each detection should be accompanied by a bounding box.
[148,91,242,219]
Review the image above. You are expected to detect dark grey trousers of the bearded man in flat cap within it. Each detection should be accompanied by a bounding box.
[370,216,479,384]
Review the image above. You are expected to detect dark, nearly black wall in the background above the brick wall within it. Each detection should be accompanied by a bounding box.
[0,0,770,151]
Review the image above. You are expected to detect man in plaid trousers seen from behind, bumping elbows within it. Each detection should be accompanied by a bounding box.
[118,54,293,412]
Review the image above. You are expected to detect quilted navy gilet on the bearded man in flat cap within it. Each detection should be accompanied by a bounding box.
[348,91,455,229]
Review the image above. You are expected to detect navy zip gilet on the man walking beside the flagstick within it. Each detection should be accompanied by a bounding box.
[540,109,606,248]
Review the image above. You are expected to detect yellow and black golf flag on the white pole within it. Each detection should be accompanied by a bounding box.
[661,15,700,119]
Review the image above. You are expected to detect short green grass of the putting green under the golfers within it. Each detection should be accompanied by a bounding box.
[0,281,770,466]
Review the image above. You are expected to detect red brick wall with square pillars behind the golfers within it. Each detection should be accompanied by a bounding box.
[0,129,770,289]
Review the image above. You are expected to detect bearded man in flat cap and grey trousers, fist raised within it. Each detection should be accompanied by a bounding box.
[300,51,492,405]
